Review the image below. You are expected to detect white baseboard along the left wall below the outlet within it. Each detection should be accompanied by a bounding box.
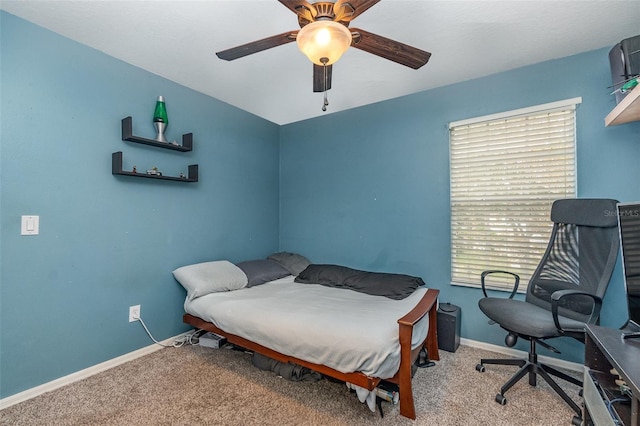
[0,330,193,410]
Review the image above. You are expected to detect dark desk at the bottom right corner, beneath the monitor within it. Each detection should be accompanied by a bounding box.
[583,325,640,426]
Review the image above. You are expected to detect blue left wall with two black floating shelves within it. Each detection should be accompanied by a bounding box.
[0,12,279,397]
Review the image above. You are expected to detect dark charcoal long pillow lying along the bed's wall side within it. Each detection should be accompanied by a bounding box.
[295,264,425,300]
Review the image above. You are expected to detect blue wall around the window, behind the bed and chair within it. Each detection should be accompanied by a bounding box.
[280,49,640,362]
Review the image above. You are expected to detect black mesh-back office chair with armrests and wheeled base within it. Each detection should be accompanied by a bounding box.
[476,199,619,422]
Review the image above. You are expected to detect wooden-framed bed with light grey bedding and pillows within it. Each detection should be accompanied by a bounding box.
[173,253,439,419]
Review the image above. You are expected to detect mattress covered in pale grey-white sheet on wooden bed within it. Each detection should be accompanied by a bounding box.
[184,276,429,379]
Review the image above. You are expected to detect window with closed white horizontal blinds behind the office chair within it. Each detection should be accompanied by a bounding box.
[449,98,581,291]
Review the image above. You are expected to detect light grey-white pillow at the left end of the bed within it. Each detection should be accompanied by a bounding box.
[173,260,249,301]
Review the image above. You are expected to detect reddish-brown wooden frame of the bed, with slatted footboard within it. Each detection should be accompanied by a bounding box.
[183,289,440,419]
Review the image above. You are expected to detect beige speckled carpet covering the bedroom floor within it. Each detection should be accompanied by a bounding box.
[0,346,581,426]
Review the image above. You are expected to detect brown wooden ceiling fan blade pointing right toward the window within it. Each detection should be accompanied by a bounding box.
[351,28,431,70]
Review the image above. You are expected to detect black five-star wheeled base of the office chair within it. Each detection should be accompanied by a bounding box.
[476,339,582,417]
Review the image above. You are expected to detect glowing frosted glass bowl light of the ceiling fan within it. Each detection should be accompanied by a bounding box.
[296,20,351,65]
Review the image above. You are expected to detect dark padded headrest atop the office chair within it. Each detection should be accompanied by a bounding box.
[551,198,618,228]
